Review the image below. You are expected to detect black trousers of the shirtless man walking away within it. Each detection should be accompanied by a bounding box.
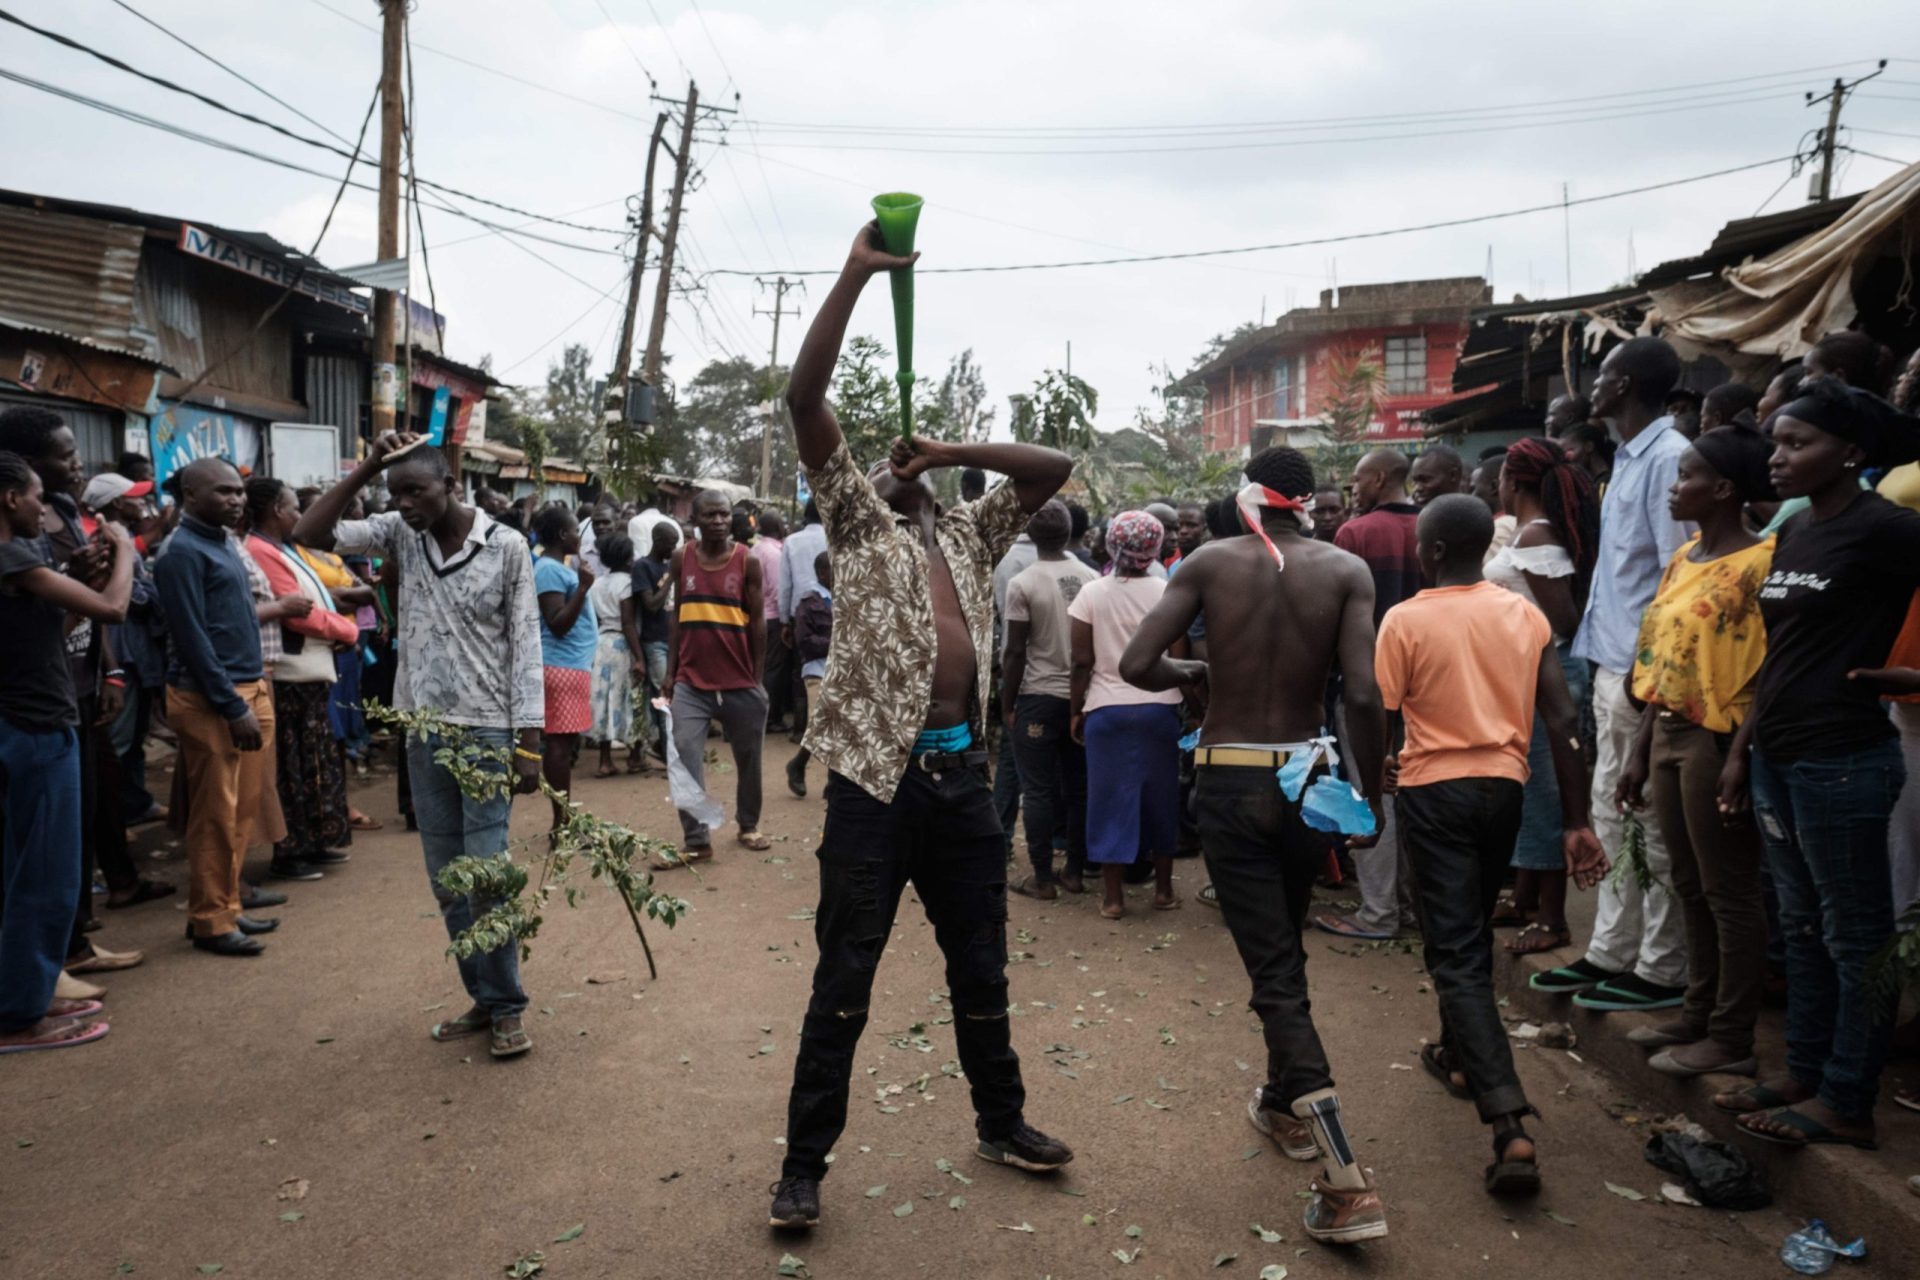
[1194,766,1332,1113]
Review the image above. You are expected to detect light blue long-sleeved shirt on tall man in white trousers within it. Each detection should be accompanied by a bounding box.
[1572,418,1693,674]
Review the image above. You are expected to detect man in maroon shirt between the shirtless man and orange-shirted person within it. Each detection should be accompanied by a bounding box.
[1313,449,1423,940]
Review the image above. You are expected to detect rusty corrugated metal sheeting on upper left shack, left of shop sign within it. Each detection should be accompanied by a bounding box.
[0,203,159,361]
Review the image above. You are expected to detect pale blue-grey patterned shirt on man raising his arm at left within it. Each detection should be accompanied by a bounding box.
[334,510,545,729]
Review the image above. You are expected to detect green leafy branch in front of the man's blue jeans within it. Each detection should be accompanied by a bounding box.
[367,702,689,977]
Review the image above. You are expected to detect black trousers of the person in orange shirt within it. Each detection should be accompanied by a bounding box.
[1396,777,1530,1121]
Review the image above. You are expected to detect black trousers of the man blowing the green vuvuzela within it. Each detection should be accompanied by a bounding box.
[781,766,1027,1178]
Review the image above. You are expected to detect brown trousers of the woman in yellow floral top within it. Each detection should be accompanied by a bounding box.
[1647,712,1766,1057]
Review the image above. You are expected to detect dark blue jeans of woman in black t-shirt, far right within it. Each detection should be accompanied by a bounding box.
[1753,741,1907,1121]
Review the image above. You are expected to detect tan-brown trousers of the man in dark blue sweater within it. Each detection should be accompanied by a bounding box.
[167,679,284,938]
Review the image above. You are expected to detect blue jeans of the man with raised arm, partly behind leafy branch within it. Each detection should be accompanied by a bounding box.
[407,729,526,1019]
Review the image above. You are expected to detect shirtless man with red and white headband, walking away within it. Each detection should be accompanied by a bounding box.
[1119,447,1386,1244]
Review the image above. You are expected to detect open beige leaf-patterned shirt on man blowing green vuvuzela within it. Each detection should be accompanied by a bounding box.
[806,443,1027,804]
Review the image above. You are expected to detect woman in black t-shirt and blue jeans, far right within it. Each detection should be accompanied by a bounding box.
[1713,378,1920,1148]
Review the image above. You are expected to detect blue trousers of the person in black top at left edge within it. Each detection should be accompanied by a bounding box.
[0,720,81,1031]
